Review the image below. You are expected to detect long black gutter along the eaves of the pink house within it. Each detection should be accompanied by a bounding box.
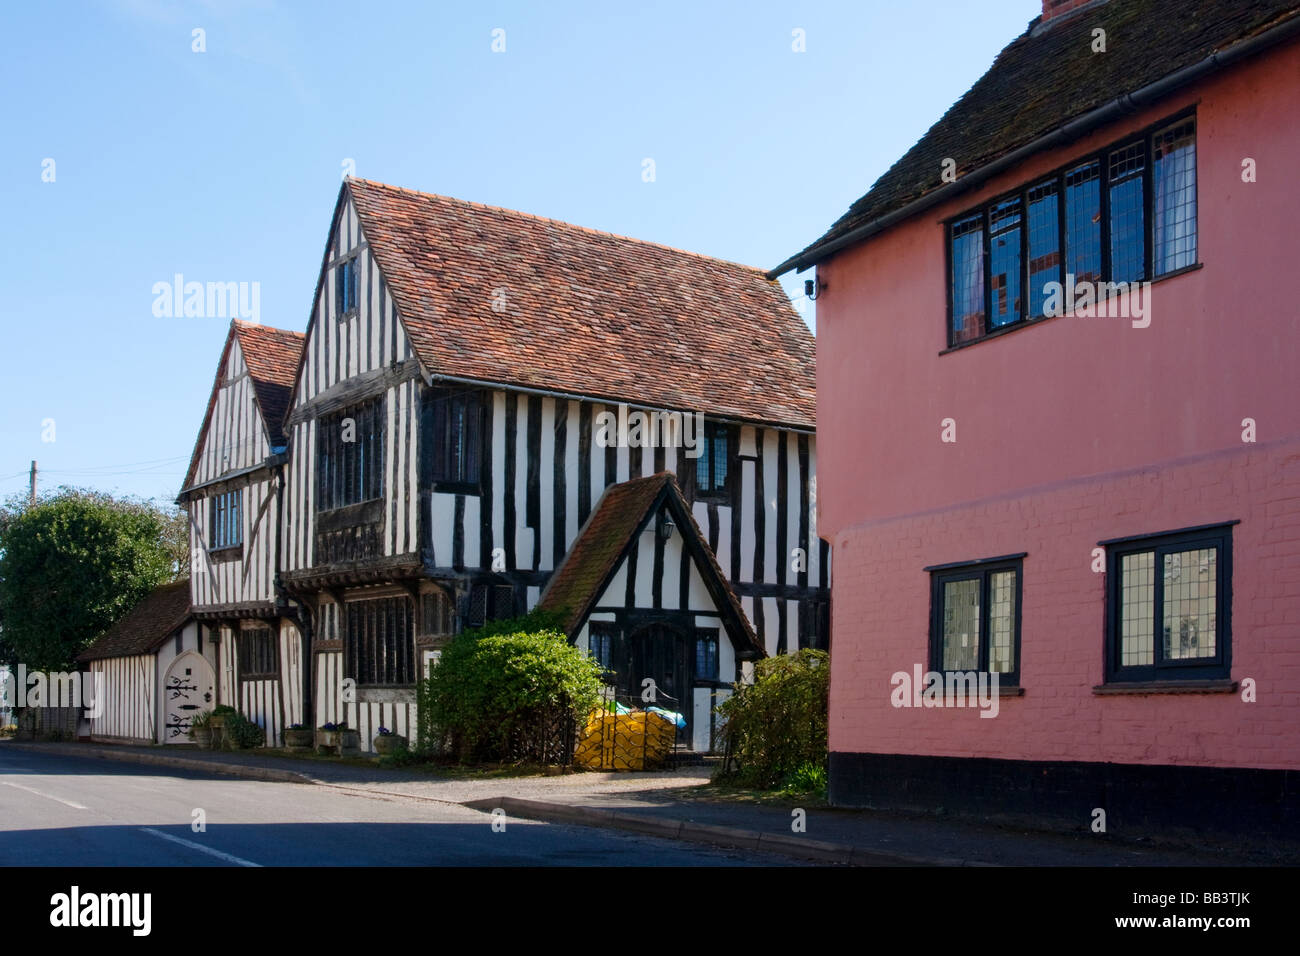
[767,16,1300,278]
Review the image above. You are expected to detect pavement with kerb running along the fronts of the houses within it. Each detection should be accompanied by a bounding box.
[0,741,1300,866]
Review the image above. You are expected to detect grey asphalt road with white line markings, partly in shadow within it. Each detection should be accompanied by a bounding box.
[0,748,792,866]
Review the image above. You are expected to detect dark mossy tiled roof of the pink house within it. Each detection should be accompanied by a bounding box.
[774,0,1300,272]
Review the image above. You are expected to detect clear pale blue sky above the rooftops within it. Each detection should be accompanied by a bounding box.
[0,0,1040,501]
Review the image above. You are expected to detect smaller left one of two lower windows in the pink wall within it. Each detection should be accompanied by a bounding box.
[931,555,1023,685]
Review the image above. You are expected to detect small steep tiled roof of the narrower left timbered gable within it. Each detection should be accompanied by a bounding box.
[181,319,306,492]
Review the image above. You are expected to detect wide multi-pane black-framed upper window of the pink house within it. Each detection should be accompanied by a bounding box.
[946,116,1196,346]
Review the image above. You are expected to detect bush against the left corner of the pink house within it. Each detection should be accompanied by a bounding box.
[718,649,831,787]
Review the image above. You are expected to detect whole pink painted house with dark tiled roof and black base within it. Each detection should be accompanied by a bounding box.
[772,0,1300,834]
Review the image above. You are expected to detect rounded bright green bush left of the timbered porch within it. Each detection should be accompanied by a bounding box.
[416,611,601,761]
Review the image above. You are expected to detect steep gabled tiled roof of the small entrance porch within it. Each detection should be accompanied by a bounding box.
[538,471,763,658]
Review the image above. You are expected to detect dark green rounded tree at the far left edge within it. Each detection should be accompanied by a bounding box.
[0,488,189,670]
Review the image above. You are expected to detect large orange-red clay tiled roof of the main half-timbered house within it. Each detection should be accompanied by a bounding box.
[343,178,816,428]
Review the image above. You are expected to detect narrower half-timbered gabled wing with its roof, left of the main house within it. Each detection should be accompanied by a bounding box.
[179,320,309,744]
